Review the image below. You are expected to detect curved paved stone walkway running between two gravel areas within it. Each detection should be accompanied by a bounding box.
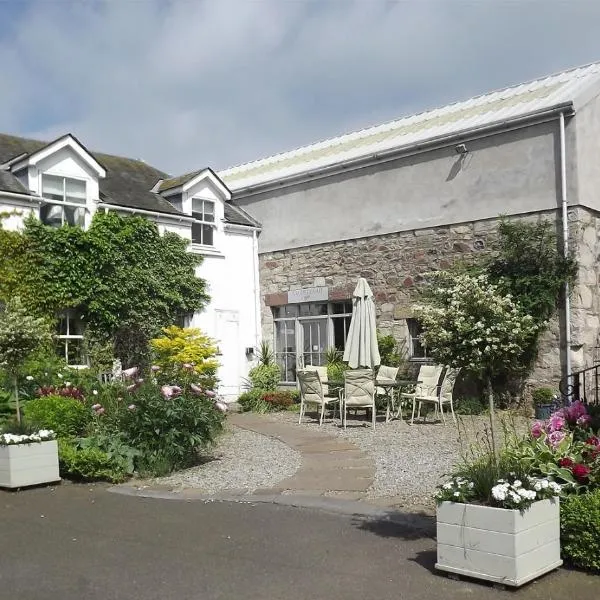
[229,413,375,500]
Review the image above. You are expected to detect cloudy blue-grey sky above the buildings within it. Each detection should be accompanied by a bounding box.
[0,0,600,173]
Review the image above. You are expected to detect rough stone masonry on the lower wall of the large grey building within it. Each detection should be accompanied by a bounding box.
[260,209,584,385]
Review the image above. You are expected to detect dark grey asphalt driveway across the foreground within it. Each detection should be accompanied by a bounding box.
[0,484,600,600]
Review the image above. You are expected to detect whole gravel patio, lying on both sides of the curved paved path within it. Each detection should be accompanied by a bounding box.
[136,412,528,508]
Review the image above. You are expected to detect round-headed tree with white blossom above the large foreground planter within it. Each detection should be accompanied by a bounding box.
[415,272,541,452]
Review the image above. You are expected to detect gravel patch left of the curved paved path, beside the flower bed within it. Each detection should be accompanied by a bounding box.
[148,427,301,494]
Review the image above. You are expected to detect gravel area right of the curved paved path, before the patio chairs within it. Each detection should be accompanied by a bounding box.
[268,412,524,506]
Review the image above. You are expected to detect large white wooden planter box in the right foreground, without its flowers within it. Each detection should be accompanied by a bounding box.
[435,498,562,586]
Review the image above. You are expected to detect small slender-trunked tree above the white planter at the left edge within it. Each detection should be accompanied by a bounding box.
[0,296,52,423]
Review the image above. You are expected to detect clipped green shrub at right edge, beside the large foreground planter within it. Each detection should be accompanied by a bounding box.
[560,490,600,571]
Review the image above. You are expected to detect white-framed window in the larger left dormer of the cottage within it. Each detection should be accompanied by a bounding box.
[40,175,86,227]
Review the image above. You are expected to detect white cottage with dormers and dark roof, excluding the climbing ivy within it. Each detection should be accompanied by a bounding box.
[0,134,260,399]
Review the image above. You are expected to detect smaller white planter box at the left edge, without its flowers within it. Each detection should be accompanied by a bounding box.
[0,440,60,488]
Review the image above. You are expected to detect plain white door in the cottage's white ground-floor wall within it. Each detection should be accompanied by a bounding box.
[215,310,241,400]
